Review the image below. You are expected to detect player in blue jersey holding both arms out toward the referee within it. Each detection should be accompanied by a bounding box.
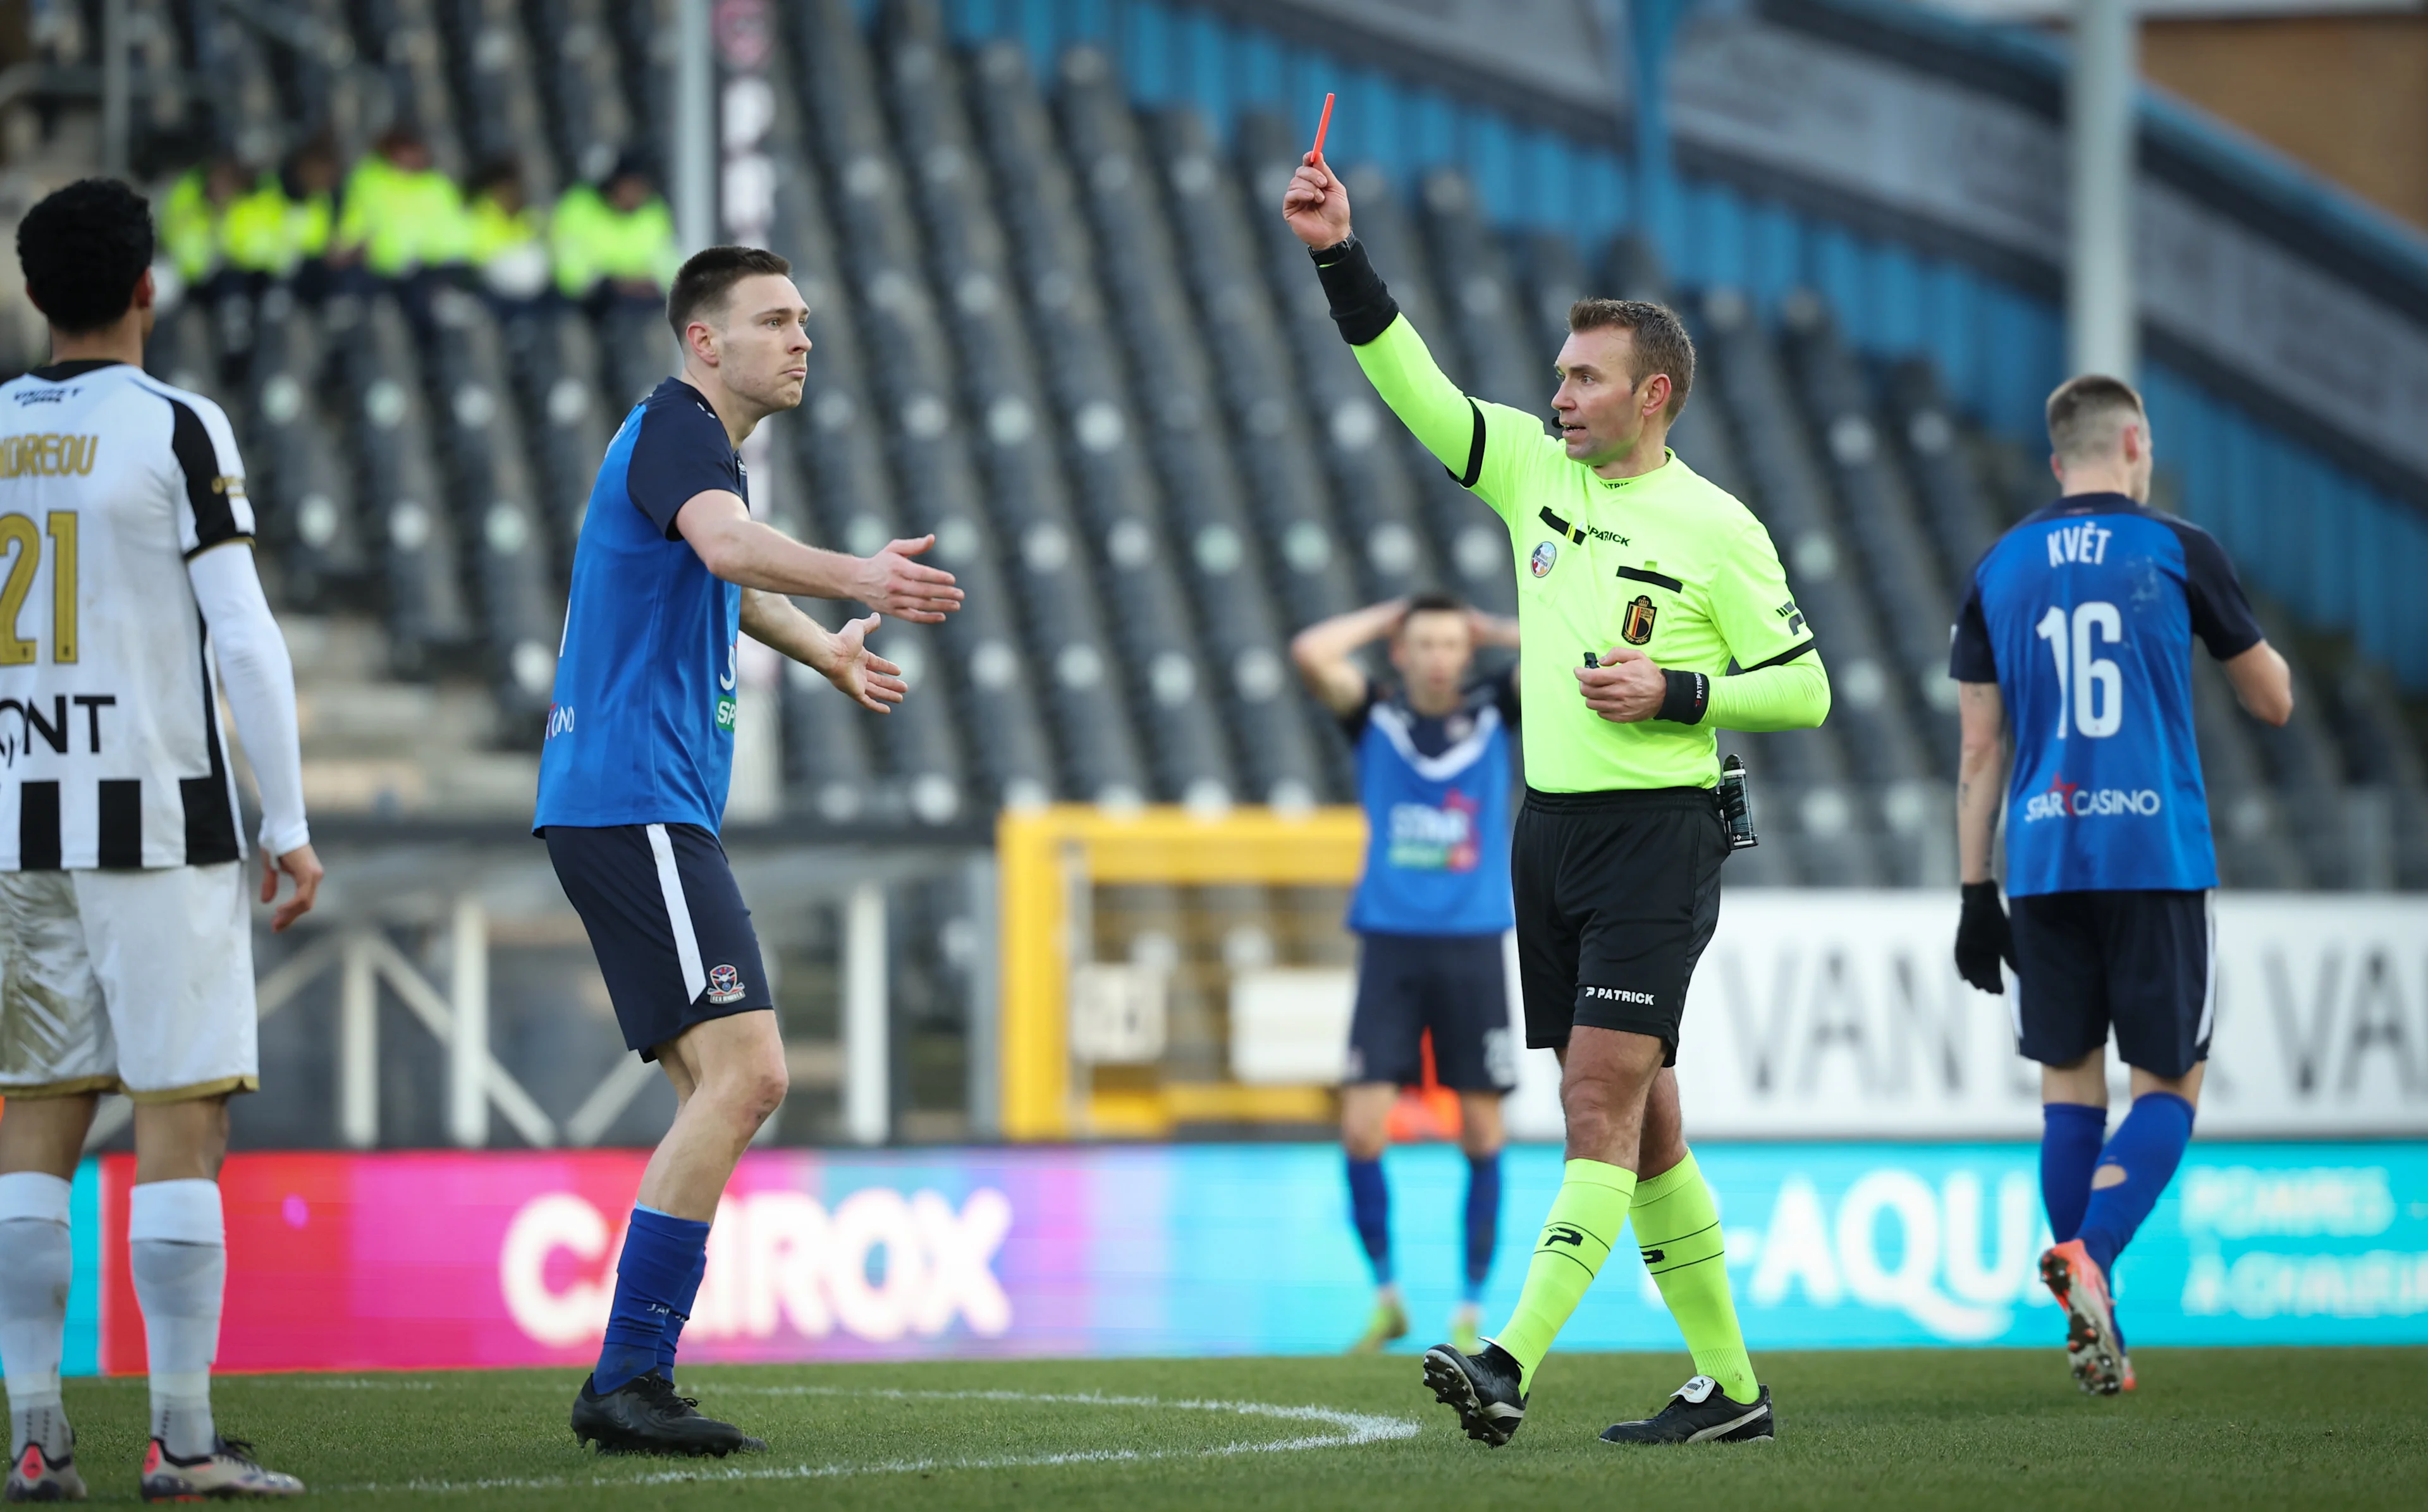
[532,248,962,1454]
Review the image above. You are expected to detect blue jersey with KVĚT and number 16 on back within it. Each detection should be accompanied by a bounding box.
[1947,492,2260,896]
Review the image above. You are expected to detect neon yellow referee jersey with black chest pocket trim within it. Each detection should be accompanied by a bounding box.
[1352,315,1829,794]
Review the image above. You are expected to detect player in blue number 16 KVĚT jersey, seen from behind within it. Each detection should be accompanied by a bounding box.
[1950,376,2292,1393]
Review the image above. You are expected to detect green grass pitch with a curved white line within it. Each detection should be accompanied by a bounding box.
[42,1350,2428,1512]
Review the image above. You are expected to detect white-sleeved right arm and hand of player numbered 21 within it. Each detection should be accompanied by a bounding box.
[185,539,321,930]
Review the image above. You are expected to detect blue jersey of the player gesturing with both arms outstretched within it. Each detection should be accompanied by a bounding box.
[532,379,751,832]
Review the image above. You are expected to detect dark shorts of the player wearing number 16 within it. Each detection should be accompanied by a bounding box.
[2008,891,2217,1078]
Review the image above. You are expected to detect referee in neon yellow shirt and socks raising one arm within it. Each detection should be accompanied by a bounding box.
[1282,153,1829,1446]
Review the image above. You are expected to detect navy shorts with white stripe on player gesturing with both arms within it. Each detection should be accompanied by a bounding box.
[546,825,775,1061]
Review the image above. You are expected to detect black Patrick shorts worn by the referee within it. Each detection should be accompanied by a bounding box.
[1510,786,1729,1066]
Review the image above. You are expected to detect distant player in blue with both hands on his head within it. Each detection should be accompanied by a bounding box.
[1289,592,1518,1352]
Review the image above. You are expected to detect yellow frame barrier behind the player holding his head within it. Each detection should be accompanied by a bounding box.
[995,803,1367,1141]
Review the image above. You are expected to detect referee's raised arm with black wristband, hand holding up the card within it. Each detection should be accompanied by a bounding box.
[1282,153,1544,509]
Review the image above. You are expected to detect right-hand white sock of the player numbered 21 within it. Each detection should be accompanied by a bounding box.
[126,1180,228,1459]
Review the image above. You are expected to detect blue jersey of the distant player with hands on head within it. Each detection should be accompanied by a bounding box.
[1343,674,1518,934]
